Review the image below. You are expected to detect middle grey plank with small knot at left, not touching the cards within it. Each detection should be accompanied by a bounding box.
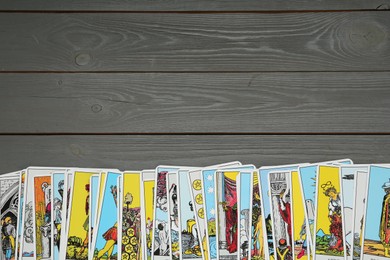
[0,72,390,133]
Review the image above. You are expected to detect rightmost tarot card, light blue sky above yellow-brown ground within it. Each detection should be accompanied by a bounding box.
[361,165,390,260]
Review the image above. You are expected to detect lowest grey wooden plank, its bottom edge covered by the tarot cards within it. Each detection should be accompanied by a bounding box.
[0,135,390,173]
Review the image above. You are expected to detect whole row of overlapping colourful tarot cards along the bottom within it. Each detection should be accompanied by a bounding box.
[0,159,390,260]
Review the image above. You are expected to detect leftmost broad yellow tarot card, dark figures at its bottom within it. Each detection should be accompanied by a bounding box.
[60,170,99,259]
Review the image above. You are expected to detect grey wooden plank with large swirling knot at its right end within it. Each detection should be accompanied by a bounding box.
[0,12,390,72]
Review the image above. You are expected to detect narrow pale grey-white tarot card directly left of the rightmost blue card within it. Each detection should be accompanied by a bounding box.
[353,171,369,260]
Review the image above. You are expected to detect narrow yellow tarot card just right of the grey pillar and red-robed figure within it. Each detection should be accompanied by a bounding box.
[291,171,310,260]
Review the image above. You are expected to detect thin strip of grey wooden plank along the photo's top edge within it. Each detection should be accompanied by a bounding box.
[0,0,390,11]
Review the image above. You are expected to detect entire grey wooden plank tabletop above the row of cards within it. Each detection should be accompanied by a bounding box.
[0,0,390,173]
